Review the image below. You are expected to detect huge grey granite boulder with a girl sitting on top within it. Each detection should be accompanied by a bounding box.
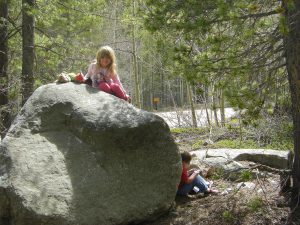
[0,83,181,225]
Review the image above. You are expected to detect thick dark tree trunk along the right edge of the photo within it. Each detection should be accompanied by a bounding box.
[282,1,300,209]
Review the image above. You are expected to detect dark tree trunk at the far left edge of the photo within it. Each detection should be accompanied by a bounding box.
[0,0,10,138]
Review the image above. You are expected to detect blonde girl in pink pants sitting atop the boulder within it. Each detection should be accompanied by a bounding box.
[85,46,130,101]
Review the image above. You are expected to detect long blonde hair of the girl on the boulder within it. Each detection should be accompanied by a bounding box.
[96,46,117,75]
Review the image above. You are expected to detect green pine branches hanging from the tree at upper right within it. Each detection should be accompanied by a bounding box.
[144,0,289,118]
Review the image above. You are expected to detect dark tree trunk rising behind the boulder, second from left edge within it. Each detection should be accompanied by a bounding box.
[22,0,35,104]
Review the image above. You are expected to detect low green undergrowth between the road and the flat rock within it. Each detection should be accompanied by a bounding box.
[171,115,294,151]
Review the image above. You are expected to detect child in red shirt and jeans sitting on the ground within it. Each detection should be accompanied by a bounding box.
[177,152,219,195]
